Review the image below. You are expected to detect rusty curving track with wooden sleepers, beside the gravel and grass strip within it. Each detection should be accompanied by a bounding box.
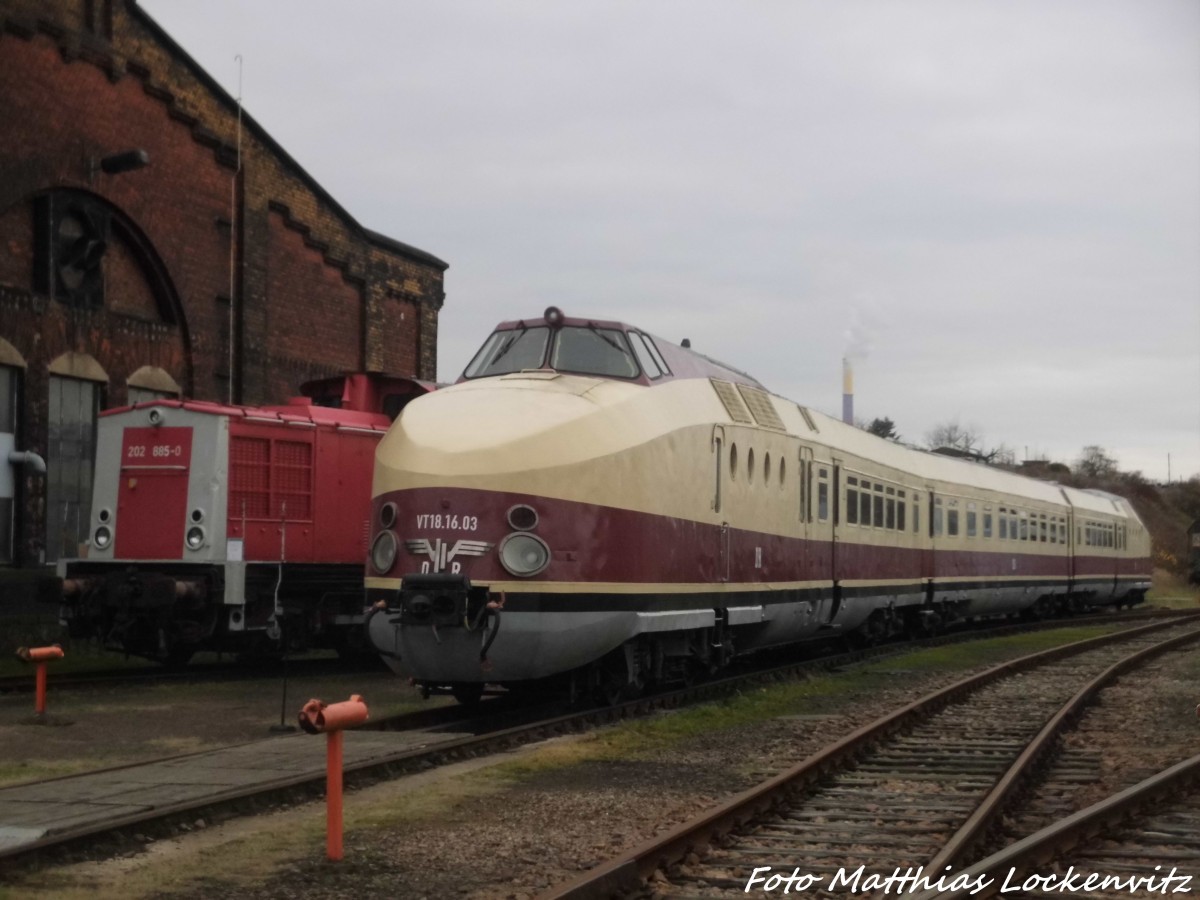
[544,617,1200,899]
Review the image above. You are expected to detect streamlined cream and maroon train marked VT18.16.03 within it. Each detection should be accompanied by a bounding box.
[366,307,1150,698]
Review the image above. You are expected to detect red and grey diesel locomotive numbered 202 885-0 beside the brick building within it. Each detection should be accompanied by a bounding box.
[58,374,433,665]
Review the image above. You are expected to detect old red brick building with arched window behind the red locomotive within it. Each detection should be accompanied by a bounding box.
[0,0,446,565]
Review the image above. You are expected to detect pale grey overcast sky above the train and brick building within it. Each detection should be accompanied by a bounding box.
[142,0,1200,480]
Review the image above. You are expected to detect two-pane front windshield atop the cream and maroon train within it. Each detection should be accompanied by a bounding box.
[463,325,640,378]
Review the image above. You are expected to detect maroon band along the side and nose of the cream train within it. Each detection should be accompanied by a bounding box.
[372,487,1148,584]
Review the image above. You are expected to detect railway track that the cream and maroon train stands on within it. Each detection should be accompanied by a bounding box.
[0,616,1178,866]
